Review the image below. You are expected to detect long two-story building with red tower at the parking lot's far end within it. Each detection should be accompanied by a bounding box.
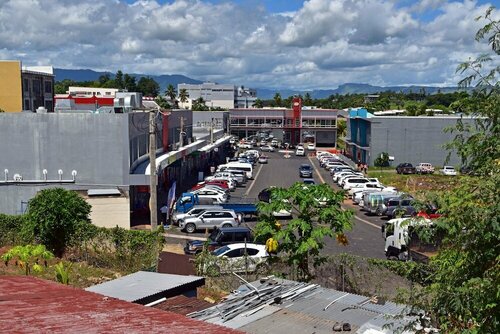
[229,98,338,147]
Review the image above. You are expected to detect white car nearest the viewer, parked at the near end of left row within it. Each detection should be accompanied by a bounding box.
[208,243,269,272]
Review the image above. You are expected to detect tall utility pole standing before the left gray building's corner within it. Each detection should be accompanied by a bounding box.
[149,110,158,231]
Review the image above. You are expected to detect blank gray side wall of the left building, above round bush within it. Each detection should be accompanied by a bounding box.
[0,113,130,214]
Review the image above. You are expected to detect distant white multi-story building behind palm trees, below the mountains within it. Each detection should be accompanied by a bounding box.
[177,82,257,109]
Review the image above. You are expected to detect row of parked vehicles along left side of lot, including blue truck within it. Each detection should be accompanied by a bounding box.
[174,150,268,272]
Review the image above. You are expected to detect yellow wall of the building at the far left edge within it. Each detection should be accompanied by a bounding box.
[0,60,23,112]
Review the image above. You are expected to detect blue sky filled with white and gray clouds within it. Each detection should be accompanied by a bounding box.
[0,0,499,90]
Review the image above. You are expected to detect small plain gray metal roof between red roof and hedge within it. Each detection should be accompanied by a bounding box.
[85,271,205,302]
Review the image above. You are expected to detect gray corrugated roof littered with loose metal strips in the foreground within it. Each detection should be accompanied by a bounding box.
[188,279,404,334]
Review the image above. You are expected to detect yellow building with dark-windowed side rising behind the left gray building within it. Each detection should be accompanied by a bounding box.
[0,61,54,112]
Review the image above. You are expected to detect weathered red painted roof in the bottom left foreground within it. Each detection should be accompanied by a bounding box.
[0,276,241,334]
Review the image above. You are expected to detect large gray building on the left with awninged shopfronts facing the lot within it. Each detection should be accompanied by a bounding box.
[0,110,229,228]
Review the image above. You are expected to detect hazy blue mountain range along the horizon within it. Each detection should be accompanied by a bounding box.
[54,68,459,100]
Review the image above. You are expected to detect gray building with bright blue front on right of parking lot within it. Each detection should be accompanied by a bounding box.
[346,109,474,167]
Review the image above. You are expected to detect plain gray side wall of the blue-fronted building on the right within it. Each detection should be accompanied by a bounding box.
[367,116,473,166]
